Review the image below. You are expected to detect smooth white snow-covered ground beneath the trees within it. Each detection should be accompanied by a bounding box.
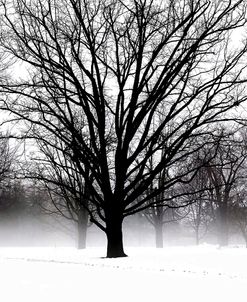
[0,245,247,302]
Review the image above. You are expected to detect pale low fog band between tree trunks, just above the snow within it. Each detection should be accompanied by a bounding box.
[0,213,244,250]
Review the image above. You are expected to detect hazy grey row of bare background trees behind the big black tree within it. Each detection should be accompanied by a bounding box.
[0,127,247,248]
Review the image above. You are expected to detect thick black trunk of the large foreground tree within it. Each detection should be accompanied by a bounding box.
[106,210,127,258]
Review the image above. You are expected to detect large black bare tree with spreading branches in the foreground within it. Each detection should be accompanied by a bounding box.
[1,0,247,257]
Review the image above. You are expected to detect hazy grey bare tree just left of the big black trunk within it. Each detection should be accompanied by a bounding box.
[26,141,93,249]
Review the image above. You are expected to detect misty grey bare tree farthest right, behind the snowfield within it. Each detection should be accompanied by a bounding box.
[206,132,247,246]
